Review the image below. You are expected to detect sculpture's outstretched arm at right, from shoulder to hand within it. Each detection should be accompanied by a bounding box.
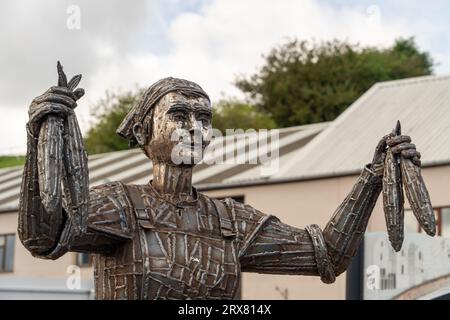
[241,136,420,283]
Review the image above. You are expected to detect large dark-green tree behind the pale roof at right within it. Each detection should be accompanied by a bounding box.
[235,38,433,127]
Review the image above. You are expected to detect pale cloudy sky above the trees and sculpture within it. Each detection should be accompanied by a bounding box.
[0,0,450,154]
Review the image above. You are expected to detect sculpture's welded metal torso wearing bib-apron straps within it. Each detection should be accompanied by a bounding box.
[95,186,240,299]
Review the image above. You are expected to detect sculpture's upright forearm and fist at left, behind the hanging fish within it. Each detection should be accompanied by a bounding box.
[18,82,83,256]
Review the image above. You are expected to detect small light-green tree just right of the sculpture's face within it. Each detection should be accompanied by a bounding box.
[212,99,276,134]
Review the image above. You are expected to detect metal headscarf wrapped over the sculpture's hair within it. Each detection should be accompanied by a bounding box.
[116,77,210,144]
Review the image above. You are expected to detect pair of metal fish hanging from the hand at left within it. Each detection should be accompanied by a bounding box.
[38,61,89,222]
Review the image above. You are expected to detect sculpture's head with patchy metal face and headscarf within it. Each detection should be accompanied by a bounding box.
[117,78,212,166]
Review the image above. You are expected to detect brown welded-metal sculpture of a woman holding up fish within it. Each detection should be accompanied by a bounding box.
[18,63,430,299]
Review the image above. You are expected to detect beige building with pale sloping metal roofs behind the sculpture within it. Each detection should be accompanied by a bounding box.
[0,76,450,299]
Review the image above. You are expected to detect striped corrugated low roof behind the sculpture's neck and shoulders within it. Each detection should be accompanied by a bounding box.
[0,122,329,211]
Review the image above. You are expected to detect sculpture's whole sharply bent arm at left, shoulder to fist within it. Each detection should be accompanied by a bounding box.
[18,65,130,259]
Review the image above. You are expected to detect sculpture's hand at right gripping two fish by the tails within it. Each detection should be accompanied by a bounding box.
[371,134,421,176]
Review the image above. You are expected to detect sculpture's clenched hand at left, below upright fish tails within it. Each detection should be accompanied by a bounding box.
[28,84,84,137]
